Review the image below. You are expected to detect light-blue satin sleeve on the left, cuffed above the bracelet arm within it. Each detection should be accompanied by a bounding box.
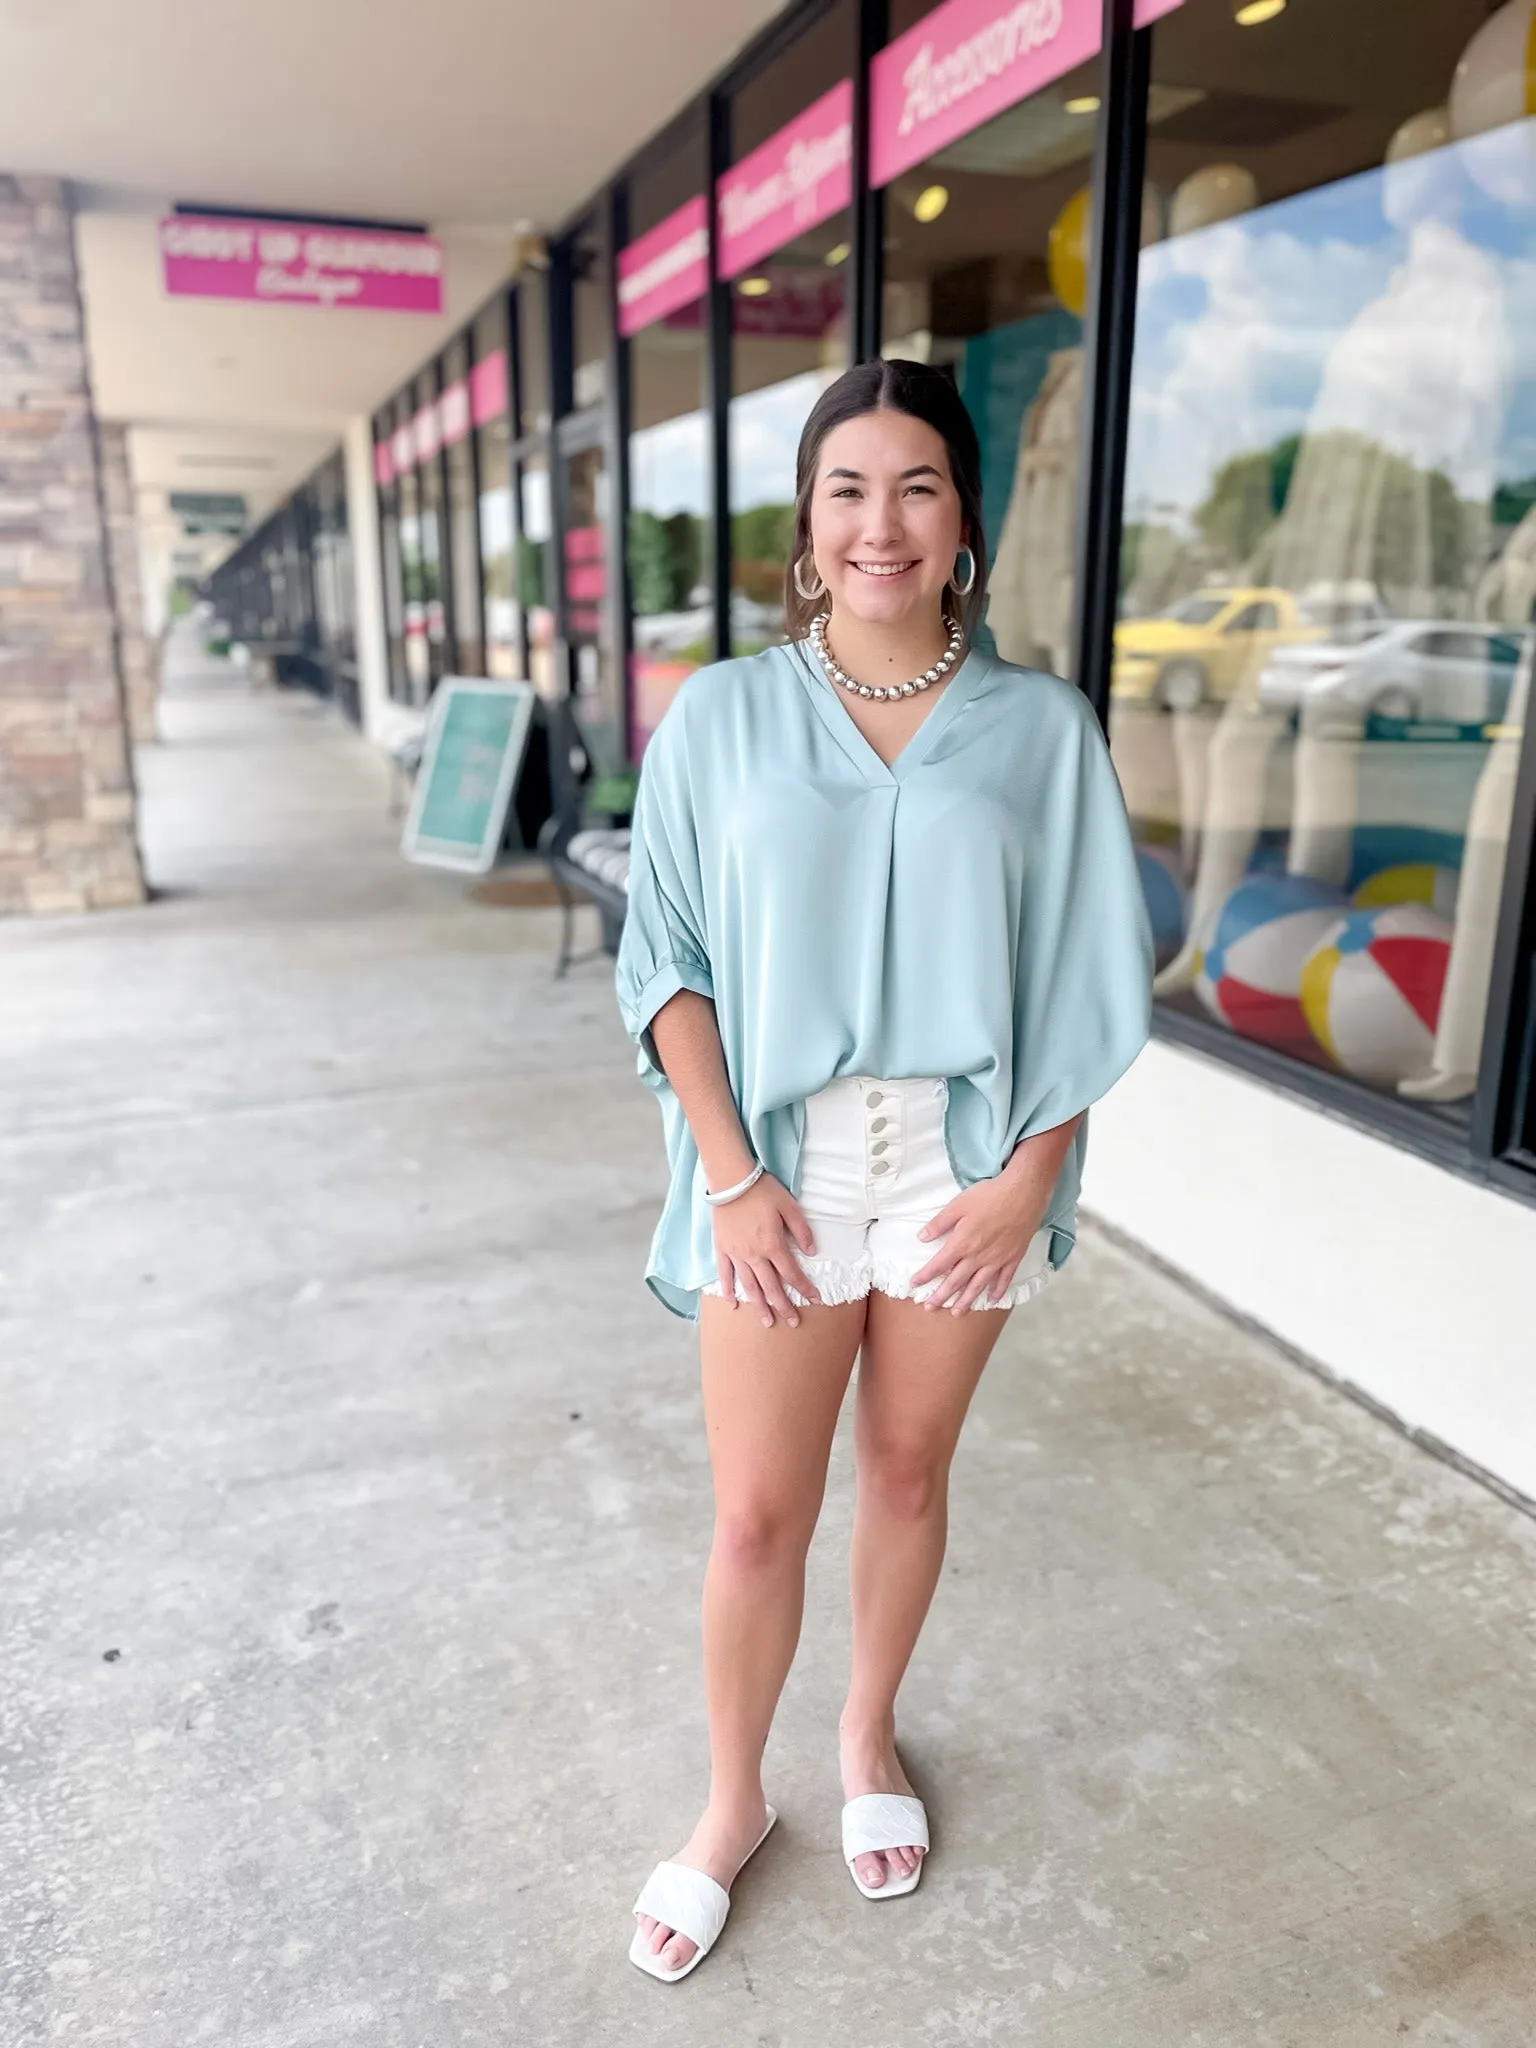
[614,705,715,1087]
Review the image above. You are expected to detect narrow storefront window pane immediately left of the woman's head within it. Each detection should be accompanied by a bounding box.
[717,4,854,653]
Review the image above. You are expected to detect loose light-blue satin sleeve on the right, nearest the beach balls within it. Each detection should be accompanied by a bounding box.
[1014,690,1153,1137]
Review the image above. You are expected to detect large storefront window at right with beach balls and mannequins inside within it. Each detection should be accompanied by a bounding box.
[1112,0,1536,1106]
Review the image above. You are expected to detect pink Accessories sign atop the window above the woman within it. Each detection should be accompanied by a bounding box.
[868,0,1182,184]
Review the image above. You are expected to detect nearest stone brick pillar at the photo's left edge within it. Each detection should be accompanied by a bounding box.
[0,174,143,913]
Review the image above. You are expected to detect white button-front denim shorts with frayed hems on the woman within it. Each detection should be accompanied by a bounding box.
[702,1075,1053,1309]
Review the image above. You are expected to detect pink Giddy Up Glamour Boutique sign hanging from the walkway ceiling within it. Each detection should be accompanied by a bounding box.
[160,213,442,313]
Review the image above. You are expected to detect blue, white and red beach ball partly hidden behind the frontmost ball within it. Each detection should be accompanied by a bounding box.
[1194,874,1348,1053]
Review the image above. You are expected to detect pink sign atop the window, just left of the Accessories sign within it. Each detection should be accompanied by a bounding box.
[715,78,854,276]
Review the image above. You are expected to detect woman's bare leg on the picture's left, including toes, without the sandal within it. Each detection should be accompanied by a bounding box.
[641,1294,864,1970]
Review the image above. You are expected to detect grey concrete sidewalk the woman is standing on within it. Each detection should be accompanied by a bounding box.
[0,630,1536,2048]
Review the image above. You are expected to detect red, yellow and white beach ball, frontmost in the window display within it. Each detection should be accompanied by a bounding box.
[1300,903,1452,1085]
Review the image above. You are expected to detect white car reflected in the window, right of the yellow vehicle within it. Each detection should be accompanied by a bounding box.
[1257,618,1526,725]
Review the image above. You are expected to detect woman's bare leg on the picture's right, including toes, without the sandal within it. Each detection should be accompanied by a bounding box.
[838,1294,1012,1884]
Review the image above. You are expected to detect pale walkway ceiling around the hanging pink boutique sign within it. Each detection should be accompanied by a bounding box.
[0,0,782,536]
